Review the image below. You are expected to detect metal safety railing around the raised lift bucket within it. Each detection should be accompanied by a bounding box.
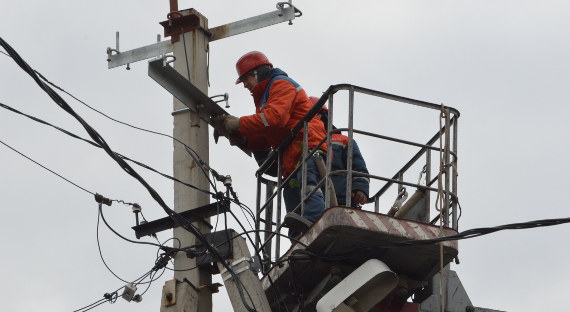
[255,84,459,268]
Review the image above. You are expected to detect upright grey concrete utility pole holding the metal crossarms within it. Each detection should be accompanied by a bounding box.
[165,10,212,311]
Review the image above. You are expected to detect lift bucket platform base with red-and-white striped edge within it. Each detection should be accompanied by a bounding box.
[262,207,458,311]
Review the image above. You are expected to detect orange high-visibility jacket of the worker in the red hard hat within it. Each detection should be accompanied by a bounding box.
[239,68,327,177]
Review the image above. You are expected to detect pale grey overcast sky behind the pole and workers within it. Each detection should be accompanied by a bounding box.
[0,0,570,311]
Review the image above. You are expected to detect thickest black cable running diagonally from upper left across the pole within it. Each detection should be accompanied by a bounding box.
[0,38,255,311]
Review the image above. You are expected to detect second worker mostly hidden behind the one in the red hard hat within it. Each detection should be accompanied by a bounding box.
[310,96,370,208]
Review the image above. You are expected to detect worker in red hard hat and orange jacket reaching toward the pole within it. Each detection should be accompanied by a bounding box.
[216,51,327,237]
